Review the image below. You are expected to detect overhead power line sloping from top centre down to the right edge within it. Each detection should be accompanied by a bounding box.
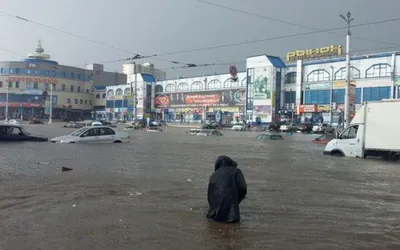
[195,0,400,46]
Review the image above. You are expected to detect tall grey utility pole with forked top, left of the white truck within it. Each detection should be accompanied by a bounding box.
[339,12,354,127]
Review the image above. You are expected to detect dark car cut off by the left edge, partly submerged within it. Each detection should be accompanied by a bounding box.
[0,125,49,142]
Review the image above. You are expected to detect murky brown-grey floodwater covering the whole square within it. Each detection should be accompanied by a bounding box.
[0,124,400,250]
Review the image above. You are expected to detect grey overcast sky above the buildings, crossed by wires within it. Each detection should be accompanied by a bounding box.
[0,0,400,78]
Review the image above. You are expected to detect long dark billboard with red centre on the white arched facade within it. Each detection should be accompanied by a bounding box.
[154,89,246,108]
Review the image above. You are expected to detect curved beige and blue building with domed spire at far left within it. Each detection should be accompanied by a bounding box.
[0,42,127,120]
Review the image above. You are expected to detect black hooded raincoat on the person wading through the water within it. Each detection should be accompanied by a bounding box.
[207,156,247,223]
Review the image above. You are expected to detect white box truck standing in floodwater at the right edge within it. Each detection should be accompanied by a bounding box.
[324,100,400,162]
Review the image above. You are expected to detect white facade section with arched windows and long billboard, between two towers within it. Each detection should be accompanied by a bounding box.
[154,72,247,123]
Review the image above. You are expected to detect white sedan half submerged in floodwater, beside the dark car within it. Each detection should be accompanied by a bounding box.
[50,126,129,143]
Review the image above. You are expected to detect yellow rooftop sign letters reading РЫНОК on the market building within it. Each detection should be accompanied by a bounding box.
[286,45,343,62]
